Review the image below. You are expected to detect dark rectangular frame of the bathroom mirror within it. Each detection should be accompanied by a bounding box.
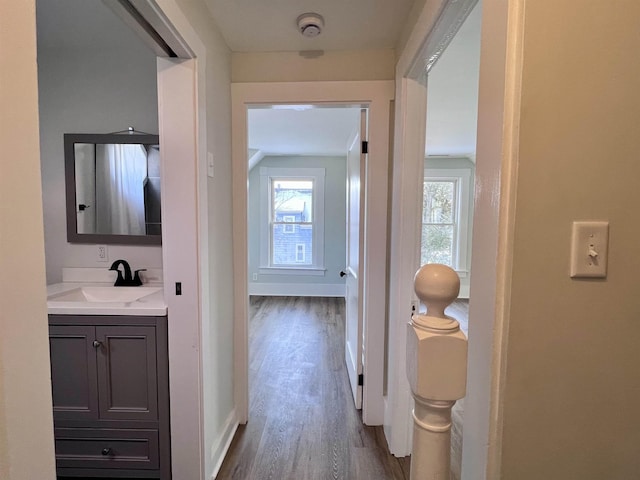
[64,133,162,245]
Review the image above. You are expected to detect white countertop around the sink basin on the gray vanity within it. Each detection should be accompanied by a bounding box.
[47,282,167,317]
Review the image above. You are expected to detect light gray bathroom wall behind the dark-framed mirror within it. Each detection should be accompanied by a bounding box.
[38,34,162,284]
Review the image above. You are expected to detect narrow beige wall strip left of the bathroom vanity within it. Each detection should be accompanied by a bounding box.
[0,0,55,480]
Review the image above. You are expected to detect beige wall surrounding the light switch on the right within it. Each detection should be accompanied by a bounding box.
[502,0,640,480]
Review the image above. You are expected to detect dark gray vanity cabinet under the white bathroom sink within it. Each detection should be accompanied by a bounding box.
[49,315,170,480]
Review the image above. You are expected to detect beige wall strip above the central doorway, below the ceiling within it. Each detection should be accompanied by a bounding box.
[231,49,395,82]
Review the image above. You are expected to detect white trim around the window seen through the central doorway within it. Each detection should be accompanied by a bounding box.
[259,167,326,275]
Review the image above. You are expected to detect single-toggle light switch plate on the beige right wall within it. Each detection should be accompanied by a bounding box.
[570,221,609,278]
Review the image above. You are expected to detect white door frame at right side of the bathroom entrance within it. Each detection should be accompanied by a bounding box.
[143,0,210,479]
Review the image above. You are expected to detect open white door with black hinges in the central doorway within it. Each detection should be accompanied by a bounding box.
[341,109,367,409]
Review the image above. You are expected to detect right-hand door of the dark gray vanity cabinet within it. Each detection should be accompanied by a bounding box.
[95,325,158,421]
